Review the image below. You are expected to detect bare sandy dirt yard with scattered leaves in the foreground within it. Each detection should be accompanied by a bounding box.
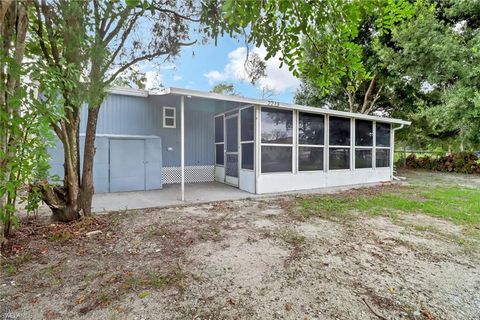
[0,174,480,320]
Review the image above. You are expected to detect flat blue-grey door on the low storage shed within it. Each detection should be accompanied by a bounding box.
[110,139,145,192]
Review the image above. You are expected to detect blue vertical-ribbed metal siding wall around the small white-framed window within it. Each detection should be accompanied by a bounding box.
[80,94,221,167]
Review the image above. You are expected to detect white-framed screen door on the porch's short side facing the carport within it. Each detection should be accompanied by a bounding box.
[225,114,238,187]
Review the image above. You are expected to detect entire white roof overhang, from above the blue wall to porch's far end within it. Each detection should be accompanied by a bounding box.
[110,87,411,125]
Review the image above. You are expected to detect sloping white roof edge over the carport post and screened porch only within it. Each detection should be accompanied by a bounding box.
[161,87,411,125]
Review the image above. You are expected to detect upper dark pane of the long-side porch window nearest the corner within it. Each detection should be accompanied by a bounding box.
[262,108,292,143]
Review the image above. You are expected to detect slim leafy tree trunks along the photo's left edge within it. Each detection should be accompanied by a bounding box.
[0,0,56,238]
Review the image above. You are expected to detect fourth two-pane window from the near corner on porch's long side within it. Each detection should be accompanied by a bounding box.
[355,119,373,169]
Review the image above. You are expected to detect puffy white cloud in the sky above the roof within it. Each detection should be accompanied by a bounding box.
[204,47,300,94]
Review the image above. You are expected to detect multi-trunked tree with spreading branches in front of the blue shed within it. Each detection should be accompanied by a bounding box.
[32,0,209,221]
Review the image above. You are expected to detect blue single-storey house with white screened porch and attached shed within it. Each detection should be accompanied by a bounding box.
[50,88,410,199]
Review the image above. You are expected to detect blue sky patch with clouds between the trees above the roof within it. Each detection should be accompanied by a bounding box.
[142,37,300,102]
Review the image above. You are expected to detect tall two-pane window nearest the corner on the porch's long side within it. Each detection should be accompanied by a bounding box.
[261,108,293,173]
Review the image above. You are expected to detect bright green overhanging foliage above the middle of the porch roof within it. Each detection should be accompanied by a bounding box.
[205,0,412,113]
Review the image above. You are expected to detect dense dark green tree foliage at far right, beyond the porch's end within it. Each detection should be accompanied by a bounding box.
[383,0,480,150]
